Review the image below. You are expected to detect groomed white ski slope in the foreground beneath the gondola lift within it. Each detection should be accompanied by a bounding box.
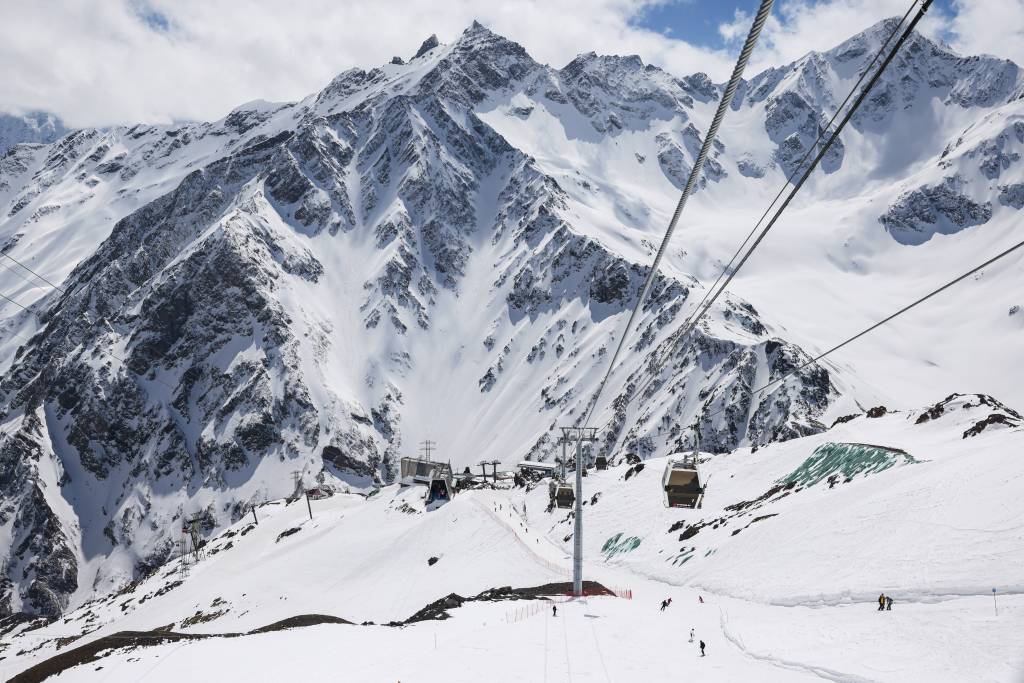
[0,396,1024,682]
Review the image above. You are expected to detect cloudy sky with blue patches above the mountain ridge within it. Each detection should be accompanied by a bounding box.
[0,0,1024,127]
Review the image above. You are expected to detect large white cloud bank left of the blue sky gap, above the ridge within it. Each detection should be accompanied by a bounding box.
[0,0,727,125]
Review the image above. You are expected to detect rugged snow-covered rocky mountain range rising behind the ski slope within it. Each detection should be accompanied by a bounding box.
[0,20,1024,615]
